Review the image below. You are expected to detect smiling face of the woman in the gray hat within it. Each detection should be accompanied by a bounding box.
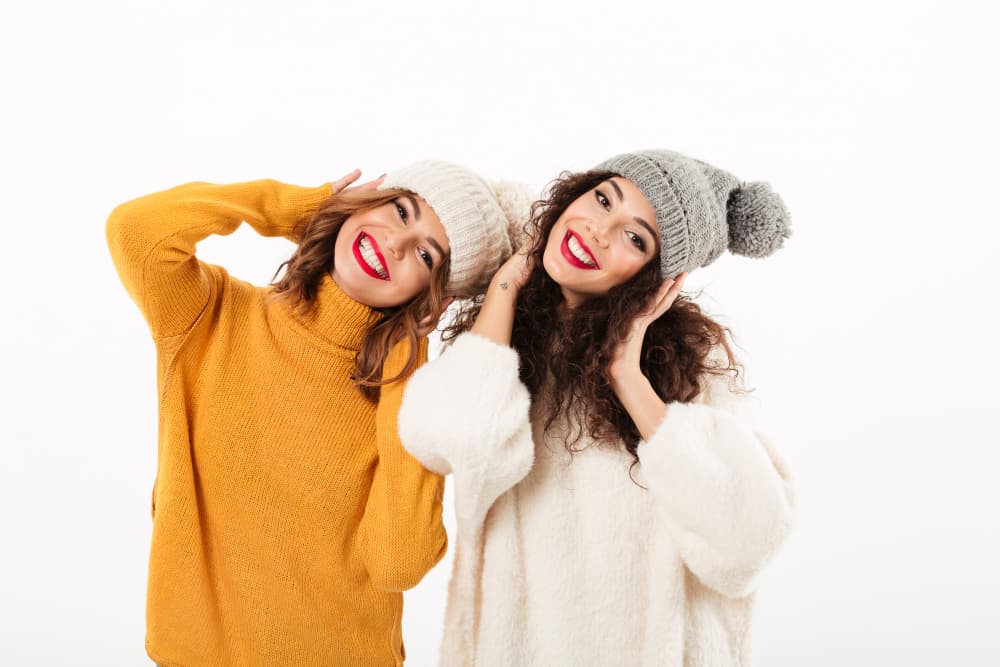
[542,176,659,308]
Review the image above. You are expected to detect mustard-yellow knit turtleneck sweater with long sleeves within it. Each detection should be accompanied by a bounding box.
[107,181,447,666]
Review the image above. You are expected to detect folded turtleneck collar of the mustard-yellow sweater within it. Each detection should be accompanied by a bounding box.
[281,274,379,352]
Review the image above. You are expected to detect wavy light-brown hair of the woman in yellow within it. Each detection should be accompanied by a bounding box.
[271,188,451,402]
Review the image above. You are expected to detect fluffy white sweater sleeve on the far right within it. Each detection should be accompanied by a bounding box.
[638,358,795,598]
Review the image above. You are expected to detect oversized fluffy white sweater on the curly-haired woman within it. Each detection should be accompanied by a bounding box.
[399,333,793,667]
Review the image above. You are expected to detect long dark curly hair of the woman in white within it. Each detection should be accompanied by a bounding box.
[443,171,745,466]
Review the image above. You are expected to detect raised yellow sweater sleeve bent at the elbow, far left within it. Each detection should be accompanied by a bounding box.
[105,180,331,338]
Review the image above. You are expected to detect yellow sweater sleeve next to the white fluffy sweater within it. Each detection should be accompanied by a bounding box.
[360,338,448,591]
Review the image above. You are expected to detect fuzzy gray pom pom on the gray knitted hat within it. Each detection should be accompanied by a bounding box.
[726,182,792,257]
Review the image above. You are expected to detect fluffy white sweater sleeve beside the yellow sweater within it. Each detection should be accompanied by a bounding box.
[399,333,535,536]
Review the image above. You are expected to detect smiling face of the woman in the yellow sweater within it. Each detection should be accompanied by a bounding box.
[333,195,451,308]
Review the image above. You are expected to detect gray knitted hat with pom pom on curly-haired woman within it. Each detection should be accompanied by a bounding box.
[594,150,791,278]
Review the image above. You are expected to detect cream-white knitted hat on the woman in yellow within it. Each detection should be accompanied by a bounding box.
[380,160,535,292]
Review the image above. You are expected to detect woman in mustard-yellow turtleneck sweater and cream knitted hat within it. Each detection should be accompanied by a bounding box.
[107,162,531,666]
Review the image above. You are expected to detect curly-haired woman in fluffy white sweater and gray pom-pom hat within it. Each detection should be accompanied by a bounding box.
[400,151,793,666]
